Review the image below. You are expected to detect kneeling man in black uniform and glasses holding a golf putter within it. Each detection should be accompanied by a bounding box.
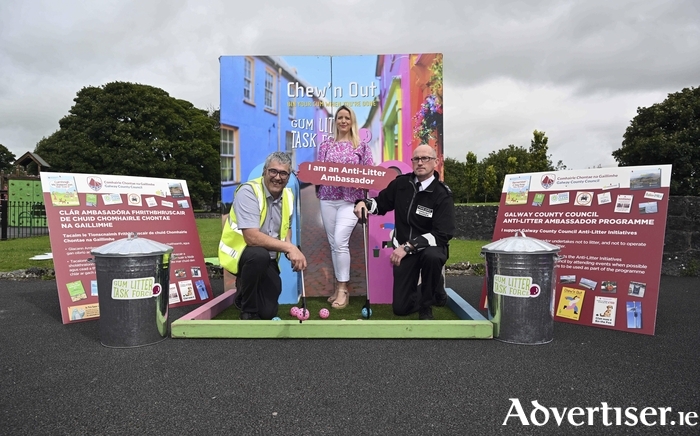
[355,144,455,319]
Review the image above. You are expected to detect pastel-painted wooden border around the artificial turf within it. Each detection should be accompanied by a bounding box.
[170,288,493,339]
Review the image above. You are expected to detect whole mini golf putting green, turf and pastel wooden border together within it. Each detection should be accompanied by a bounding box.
[170,288,493,339]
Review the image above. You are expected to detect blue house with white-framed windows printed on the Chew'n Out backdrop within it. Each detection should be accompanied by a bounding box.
[219,56,332,210]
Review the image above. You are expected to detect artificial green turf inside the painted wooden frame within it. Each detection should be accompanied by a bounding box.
[214,296,459,321]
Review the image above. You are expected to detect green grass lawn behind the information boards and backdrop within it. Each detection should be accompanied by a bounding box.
[0,218,491,272]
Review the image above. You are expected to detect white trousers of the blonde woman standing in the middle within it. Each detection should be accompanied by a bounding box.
[321,200,357,282]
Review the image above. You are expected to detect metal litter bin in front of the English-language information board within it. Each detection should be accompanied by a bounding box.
[481,232,561,345]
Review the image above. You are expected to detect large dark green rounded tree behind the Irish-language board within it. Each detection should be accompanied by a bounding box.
[35,82,220,207]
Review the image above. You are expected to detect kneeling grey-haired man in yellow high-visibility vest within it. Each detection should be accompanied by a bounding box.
[219,152,306,320]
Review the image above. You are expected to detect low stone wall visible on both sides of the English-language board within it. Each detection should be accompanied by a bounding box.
[455,196,700,277]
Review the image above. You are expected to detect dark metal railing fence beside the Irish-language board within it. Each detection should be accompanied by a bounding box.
[0,199,49,241]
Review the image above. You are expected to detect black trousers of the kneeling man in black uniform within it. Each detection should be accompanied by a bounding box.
[392,247,447,316]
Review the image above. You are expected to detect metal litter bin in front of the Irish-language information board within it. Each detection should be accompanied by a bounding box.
[90,233,173,348]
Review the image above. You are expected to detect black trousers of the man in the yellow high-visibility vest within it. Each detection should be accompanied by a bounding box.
[236,247,282,319]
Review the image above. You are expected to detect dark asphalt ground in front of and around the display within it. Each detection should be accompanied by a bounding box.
[0,276,700,435]
